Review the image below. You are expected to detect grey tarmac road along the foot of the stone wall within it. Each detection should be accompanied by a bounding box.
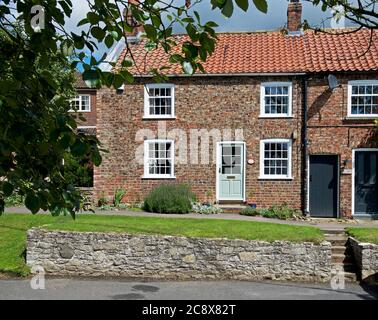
[0,278,378,300]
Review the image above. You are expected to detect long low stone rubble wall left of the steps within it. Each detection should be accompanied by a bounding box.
[27,228,331,282]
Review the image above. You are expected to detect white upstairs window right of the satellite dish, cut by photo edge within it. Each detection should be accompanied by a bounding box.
[348,80,378,118]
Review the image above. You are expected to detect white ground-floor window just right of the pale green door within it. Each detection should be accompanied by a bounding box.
[260,139,292,179]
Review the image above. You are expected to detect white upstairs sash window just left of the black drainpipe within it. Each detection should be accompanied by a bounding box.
[260,82,292,118]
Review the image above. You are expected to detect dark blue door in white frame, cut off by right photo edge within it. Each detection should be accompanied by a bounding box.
[354,151,378,214]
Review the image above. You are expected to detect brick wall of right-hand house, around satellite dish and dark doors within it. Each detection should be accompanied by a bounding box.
[308,73,378,216]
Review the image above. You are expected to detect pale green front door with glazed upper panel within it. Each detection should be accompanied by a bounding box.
[218,143,245,200]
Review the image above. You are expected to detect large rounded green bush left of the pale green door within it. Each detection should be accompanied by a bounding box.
[143,185,196,214]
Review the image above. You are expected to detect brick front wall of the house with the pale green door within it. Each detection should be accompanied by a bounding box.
[94,77,302,208]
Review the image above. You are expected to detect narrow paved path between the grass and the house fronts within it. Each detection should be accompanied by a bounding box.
[5,207,378,229]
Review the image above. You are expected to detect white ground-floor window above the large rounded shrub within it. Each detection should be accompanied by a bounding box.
[144,140,174,178]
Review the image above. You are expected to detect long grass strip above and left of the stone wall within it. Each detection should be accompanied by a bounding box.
[0,213,323,275]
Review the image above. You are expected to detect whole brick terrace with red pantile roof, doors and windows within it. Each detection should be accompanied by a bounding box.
[94,1,378,217]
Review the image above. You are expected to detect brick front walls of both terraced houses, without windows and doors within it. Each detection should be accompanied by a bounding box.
[94,73,378,216]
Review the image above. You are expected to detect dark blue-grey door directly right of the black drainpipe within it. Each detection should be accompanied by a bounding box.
[310,155,339,218]
